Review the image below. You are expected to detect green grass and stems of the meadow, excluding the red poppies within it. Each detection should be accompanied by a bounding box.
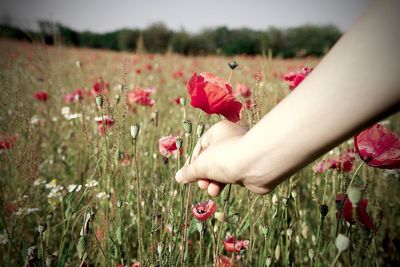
[0,40,400,266]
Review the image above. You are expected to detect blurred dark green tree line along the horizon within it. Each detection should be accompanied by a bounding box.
[0,21,342,58]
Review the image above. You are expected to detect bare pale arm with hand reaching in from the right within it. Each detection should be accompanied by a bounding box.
[175,0,400,196]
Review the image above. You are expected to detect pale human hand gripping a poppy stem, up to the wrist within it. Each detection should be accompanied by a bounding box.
[175,120,276,196]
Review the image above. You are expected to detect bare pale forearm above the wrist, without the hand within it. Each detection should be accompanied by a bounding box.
[241,1,400,188]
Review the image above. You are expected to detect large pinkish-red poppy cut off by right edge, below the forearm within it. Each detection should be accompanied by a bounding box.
[354,124,400,169]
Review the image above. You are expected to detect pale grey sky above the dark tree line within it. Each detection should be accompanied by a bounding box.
[0,0,371,32]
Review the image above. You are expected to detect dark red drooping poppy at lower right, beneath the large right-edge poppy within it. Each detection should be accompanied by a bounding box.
[336,194,374,230]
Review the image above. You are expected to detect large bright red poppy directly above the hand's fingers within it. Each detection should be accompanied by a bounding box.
[187,72,242,122]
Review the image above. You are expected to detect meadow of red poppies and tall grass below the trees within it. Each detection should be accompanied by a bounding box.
[0,40,400,266]
